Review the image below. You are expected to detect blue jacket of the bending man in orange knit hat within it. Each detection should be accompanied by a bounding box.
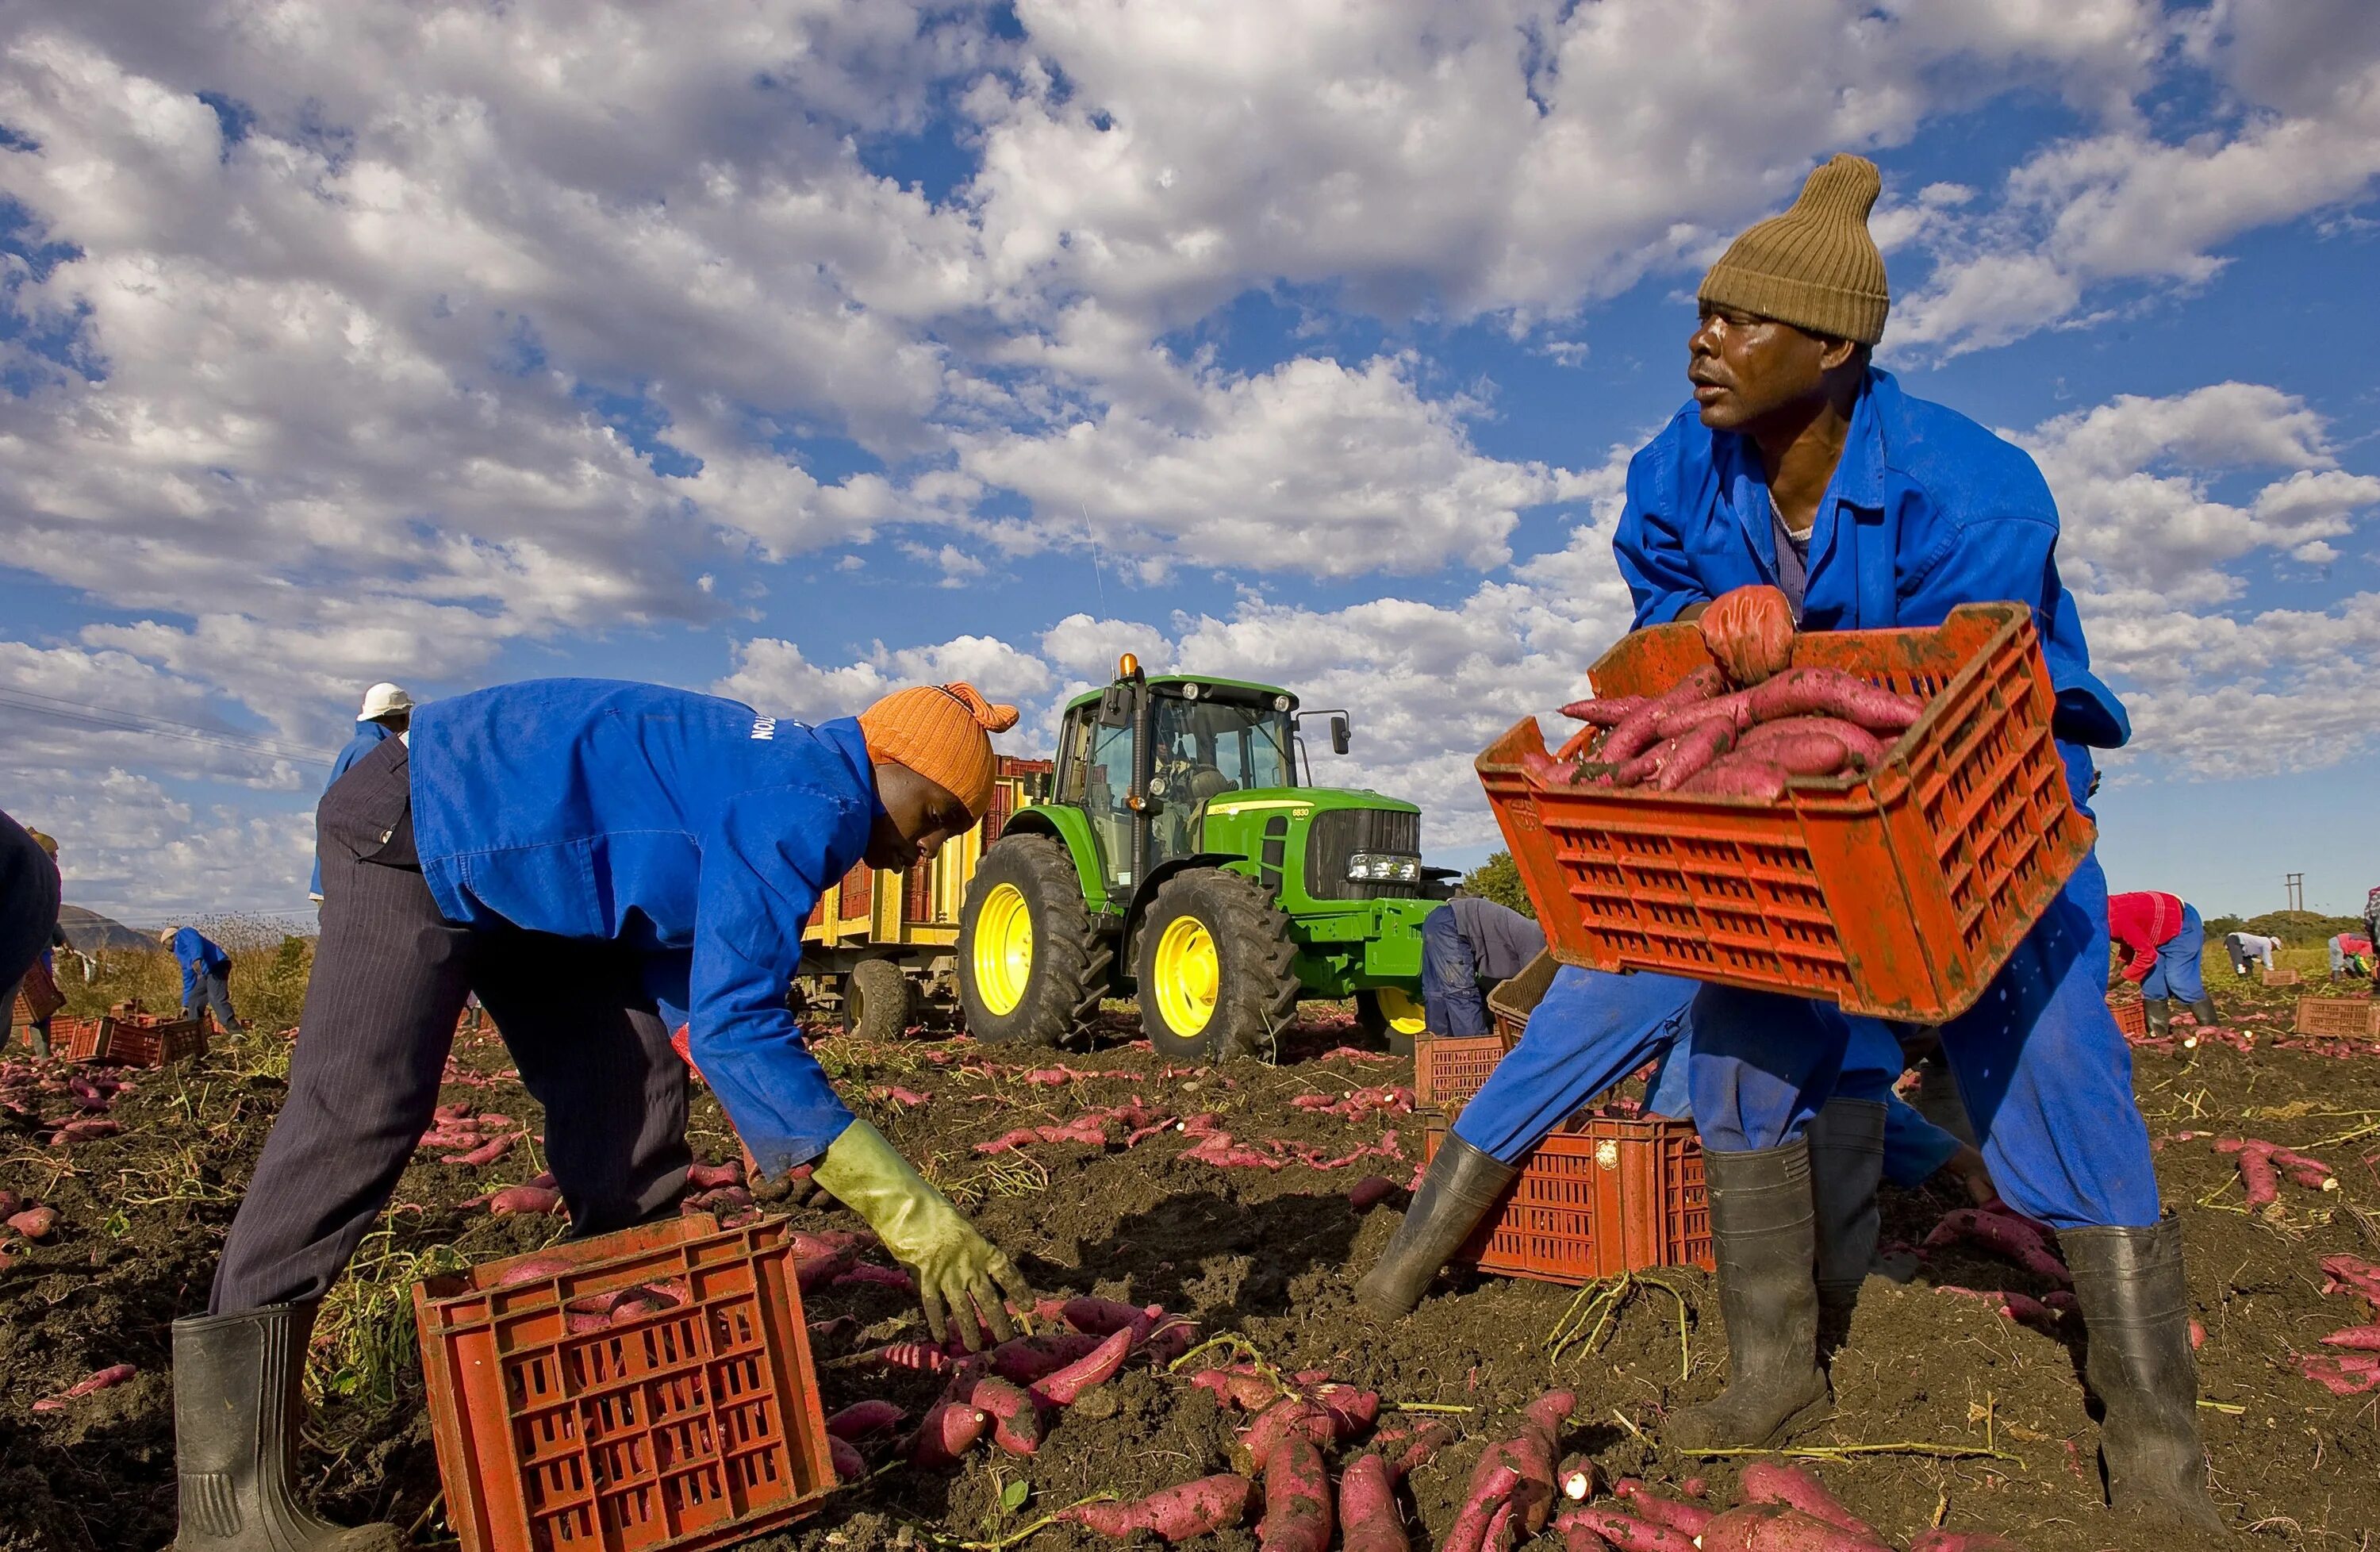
[409,678,883,1176]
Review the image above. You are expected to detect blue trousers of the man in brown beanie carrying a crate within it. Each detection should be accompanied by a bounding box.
[1690,745,2159,1228]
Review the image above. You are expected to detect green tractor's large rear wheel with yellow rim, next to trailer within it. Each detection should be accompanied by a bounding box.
[959,836,1116,1045]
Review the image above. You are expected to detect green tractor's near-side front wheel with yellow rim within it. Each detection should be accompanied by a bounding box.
[1135,866,1299,1062]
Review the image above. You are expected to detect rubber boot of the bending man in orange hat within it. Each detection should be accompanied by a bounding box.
[174,1304,405,1552]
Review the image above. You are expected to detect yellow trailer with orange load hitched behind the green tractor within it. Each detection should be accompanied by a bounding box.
[793,755,1054,1040]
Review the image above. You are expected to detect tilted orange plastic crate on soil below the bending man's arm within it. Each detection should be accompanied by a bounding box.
[414,1214,835,1552]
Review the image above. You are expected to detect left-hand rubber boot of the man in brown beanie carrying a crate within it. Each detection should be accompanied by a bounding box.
[1668,1138,1830,1450]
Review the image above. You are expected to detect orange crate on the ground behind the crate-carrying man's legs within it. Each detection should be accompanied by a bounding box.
[1421,1114,1711,1285]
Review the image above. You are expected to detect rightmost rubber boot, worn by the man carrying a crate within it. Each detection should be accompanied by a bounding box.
[2059,1212,2223,1535]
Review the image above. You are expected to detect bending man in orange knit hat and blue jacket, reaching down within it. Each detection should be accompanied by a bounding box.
[174,678,1033,1552]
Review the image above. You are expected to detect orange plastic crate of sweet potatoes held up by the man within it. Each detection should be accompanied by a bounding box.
[1478,605,2094,1024]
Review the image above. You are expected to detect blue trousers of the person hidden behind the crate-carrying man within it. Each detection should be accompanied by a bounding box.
[1454,964,1959,1185]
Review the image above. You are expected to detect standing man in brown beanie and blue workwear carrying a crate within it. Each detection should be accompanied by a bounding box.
[1614,157,2218,1528]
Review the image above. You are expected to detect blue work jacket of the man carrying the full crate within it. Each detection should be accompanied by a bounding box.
[1611,369,2132,750]
